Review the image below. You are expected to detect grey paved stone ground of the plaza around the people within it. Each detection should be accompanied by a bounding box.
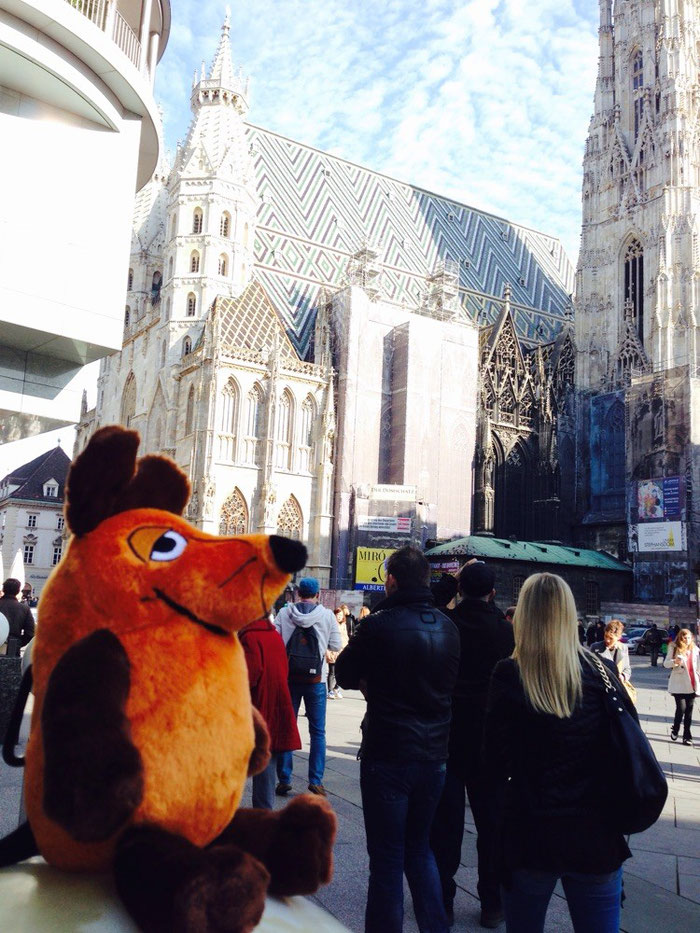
[0,658,700,933]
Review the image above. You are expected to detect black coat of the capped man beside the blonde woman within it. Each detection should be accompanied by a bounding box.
[446,596,515,777]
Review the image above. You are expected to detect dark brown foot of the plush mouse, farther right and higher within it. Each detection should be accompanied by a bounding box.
[265,794,337,897]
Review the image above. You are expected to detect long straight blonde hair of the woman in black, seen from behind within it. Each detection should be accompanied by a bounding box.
[513,573,583,719]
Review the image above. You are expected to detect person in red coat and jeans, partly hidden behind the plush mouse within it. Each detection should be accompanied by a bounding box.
[238,619,301,810]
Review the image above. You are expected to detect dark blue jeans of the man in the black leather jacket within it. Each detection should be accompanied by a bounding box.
[360,758,448,933]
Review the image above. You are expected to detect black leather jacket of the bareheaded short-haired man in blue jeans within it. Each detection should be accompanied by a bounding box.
[335,587,459,761]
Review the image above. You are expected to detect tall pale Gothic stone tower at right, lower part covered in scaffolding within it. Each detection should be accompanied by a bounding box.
[576,0,700,607]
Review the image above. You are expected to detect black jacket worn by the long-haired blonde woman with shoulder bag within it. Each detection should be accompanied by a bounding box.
[483,659,637,881]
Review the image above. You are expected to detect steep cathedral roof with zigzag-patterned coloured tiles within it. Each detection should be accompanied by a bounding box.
[247,125,574,356]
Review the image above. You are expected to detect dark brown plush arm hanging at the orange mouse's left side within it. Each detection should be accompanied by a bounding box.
[41,629,143,842]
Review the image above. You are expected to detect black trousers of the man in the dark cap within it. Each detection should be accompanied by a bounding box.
[430,761,501,910]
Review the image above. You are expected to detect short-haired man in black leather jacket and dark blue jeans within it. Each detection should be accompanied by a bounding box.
[335,547,459,933]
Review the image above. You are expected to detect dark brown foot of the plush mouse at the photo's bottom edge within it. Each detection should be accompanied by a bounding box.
[172,846,270,933]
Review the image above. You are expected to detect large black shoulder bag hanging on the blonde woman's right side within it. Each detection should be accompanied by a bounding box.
[587,652,668,835]
